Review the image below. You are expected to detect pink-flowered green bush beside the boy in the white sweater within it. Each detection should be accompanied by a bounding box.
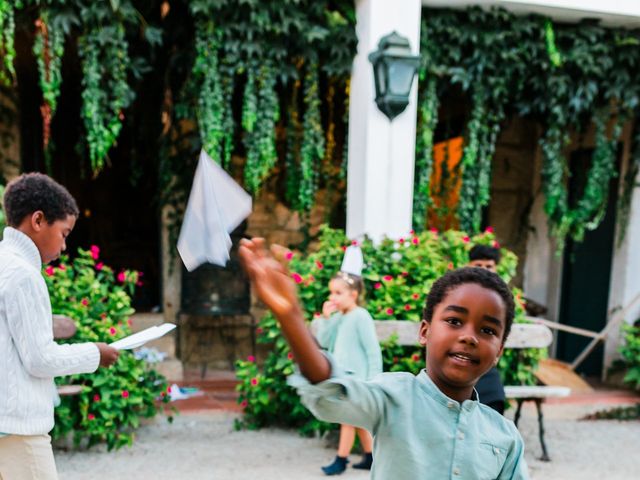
[44,246,169,449]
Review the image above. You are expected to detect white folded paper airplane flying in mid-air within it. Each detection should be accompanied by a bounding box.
[178,150,251,272]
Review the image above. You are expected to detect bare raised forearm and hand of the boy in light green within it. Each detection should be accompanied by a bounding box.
[239,238,331,383]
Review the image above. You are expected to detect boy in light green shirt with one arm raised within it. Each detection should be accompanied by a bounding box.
[240,239,528,480]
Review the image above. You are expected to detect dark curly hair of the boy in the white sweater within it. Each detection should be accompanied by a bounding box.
[4,173,79,227]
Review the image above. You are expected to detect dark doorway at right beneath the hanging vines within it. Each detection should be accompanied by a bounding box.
[557,149,618,376]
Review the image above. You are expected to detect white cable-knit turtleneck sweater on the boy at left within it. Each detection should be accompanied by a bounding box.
[0,227,100,435]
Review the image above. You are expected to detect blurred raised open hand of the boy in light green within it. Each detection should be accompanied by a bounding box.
[239,238,300,320]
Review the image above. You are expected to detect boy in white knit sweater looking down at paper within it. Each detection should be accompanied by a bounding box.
[0,173,118,480]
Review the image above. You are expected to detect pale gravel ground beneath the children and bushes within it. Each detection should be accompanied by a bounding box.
[56,405,640,480]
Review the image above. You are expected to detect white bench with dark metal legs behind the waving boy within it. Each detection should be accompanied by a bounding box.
[311,320,571,462]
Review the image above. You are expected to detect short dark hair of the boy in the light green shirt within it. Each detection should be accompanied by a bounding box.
[423,267,515,343]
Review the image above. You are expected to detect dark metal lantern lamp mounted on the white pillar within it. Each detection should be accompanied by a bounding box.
[369,31,420,120]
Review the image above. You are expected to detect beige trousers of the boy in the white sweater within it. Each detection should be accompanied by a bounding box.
[0,435,58,480]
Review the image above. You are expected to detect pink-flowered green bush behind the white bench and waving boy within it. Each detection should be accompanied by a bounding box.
[236,227,543,434]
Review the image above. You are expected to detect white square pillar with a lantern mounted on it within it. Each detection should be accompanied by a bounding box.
[347,0,421,240]
